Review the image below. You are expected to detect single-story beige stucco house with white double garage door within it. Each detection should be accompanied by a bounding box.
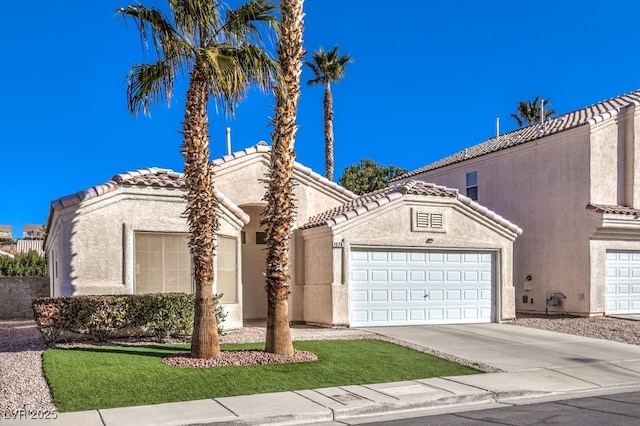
[45,144,521,328]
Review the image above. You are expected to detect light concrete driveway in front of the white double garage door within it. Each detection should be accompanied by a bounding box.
[361,324,640,371]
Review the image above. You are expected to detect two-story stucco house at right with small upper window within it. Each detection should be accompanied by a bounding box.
[395,91,640,316]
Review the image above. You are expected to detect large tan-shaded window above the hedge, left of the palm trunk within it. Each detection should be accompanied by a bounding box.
[135,232,193,294]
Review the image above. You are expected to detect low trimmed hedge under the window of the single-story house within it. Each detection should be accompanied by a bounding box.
[31,293,227,344]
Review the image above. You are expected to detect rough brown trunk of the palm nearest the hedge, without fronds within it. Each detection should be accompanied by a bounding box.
[182,65,220,359]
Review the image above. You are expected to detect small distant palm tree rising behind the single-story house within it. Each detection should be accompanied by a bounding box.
[304,46,353,180]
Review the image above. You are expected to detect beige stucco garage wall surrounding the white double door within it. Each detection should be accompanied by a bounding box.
[303,195,516,326]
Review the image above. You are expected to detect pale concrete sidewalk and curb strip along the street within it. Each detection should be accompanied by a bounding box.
[28,378,640,426]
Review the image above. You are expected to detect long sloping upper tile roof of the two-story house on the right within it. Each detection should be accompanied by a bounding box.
[392,90,640,181]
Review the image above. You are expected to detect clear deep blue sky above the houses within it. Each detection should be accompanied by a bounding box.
[0,0,640,237]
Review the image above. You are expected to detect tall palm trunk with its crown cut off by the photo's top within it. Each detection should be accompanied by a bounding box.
[262,0,304,355]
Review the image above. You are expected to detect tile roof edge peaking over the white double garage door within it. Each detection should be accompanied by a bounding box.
[301,180,522,235]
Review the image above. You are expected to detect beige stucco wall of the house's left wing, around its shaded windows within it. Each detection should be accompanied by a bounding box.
[45,187,244,328]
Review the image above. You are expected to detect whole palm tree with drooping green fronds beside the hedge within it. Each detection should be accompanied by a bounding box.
[117,0,277,358]
